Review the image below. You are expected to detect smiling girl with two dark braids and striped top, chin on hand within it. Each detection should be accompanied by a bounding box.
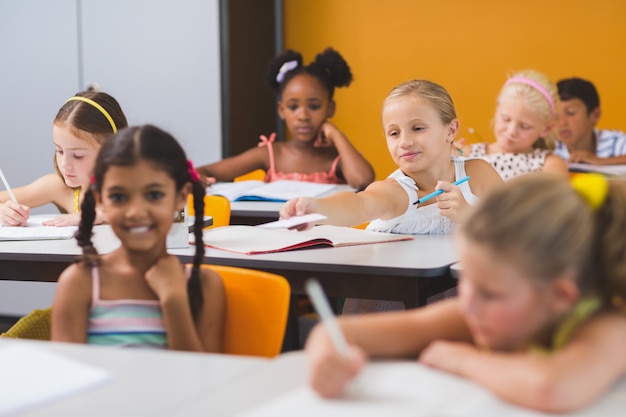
[52,125,225,352]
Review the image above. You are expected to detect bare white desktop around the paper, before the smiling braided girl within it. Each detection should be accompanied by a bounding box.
[0,338,270,417]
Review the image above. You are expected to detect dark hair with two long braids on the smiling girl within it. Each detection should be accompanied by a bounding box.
[75,125,205,317]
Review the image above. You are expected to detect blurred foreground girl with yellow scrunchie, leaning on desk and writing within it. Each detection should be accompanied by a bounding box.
[306,173,626,412]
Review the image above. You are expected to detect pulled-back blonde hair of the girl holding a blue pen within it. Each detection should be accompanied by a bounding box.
[383,80,456,124]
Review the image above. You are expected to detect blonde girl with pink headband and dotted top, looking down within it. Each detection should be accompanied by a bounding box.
[453,70,568,181]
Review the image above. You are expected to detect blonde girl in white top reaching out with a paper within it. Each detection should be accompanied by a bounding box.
[280,80,502,313]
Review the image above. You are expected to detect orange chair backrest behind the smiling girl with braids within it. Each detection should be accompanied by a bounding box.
[202,265,291,358]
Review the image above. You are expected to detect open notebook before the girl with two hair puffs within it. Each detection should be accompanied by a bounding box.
[207,180,335,202]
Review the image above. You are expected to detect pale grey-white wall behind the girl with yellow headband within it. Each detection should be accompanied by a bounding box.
[0,0,221,315]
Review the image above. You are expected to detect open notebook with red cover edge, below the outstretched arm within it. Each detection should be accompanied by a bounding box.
[204,225,413,255]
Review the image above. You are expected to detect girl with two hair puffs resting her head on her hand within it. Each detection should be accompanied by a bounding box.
[198,48,374,189]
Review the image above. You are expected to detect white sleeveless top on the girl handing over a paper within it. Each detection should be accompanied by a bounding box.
[367,156,478,235]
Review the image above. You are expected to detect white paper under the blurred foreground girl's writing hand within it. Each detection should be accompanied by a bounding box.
[236,362,545,417]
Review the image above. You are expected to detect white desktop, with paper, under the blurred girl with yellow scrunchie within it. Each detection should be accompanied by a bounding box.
[172,352,626,417]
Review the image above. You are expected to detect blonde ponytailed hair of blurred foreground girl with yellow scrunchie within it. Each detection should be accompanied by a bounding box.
[461,173,626,305]
